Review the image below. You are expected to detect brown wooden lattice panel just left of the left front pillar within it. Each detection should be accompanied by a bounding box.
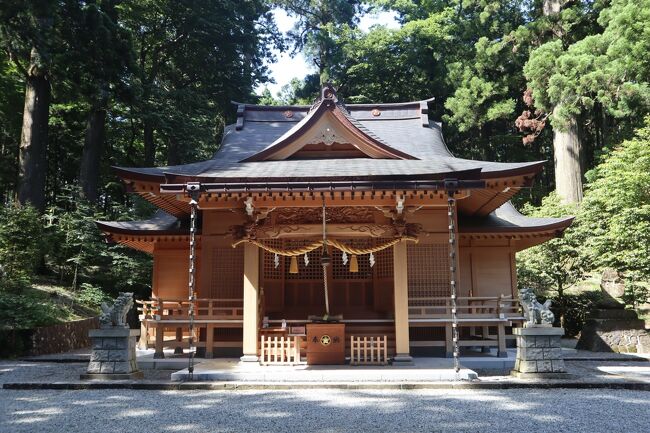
[210,247,244,299]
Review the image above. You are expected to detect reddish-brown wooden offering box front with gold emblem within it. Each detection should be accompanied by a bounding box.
[307,323,345,365]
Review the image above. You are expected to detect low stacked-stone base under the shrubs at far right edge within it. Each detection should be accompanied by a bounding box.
[576,309,650,353]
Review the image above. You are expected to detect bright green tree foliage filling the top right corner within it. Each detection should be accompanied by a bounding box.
[524,0,650,128]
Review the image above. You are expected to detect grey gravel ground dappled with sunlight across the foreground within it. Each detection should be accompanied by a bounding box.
[0,389,650,433]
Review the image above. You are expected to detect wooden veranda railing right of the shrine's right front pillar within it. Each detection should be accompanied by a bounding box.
[409,295,521,319]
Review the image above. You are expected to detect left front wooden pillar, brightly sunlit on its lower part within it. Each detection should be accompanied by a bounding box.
[241,243,260,362]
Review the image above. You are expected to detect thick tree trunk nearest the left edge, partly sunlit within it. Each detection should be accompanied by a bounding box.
[18,48,50,212]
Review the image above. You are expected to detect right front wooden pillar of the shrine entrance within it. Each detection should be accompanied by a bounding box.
[393,241,413,363]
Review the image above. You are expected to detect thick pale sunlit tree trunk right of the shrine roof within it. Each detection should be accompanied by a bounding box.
[553,114,584,203]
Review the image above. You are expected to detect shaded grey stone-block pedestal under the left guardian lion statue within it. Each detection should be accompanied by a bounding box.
[81,328,143,380]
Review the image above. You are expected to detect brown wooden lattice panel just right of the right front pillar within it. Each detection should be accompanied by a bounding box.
[407,244,450,306]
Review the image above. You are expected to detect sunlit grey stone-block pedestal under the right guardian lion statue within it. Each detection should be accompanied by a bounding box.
[511,326,567,378]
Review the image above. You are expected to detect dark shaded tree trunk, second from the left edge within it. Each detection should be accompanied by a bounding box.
[79,104,106,203]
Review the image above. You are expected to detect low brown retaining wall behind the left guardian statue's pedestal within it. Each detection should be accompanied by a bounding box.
[26,317,99,355]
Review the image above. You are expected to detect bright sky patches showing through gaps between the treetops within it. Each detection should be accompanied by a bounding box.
[256,9,399,96]
